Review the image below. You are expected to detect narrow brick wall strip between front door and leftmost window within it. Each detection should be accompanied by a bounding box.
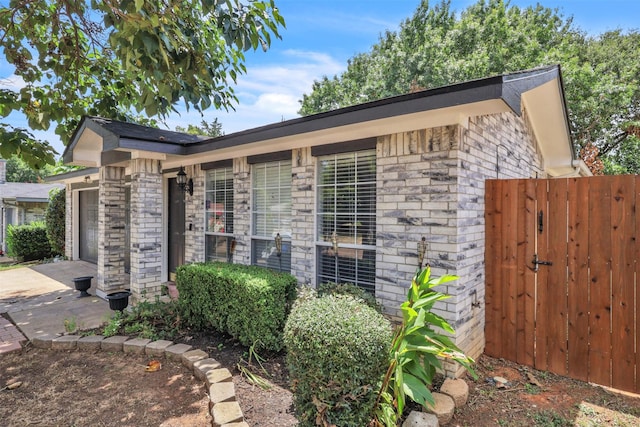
[184,165,205,264]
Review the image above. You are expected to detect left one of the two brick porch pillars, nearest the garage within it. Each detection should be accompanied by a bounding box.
[97,166,126,297]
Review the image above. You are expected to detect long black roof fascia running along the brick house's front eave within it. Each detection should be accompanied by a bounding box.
[63,65,566,162]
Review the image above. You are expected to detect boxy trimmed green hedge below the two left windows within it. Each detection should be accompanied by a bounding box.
[176,262,297,351]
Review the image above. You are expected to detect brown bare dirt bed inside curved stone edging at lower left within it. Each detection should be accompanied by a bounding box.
[0,347,211,427]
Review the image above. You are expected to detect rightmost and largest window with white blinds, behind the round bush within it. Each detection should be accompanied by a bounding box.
[316,150,376,293]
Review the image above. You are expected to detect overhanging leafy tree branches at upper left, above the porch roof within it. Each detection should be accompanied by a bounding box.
[0,0,285,166]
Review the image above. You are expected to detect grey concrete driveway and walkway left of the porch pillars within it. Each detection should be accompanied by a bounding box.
[0,261,113,353]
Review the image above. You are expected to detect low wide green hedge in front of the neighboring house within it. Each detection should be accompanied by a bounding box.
[7,221,51,261]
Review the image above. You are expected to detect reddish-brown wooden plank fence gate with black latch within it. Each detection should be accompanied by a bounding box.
[485,175,640,393]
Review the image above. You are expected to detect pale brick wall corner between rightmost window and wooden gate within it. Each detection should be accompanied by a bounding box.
[376,113,542,375]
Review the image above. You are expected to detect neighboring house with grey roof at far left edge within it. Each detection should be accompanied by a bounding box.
[0,159,64,255]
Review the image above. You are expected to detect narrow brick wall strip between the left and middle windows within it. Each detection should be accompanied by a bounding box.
[233,157,251,265]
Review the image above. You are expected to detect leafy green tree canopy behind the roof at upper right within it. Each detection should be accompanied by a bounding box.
[299,0,640,173]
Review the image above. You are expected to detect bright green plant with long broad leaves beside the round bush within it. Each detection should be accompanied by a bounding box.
[376,266,475,427]
